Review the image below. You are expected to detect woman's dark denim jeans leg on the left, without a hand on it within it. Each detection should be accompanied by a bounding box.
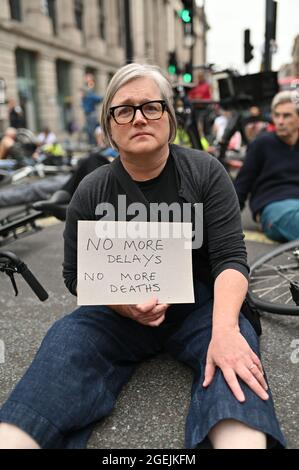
[0,307,159,448]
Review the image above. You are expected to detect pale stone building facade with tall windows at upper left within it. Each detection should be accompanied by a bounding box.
[0,0,205,133]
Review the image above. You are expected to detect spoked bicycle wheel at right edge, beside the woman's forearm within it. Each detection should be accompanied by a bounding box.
[248,240,299,316]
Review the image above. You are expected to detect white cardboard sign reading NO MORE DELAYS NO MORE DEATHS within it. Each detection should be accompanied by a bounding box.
[77,221,194,305]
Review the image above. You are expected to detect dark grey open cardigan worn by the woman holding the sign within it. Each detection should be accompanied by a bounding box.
[63,145,249,295]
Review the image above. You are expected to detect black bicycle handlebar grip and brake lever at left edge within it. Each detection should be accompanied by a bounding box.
[0,251,49,302]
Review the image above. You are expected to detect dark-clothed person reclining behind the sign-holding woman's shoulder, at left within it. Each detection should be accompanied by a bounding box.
[32,127,117,220]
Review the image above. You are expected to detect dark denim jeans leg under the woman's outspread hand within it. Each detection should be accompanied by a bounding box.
[166,282,286,448]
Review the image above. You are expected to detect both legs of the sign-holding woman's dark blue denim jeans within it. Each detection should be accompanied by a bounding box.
[0,284,285,449]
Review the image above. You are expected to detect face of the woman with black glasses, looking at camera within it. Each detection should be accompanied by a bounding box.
[110,78,170,157]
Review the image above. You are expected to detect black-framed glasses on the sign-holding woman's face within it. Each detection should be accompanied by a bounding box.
[109,100,166,125]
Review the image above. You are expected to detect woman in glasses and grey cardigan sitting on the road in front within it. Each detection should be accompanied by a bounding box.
[0,63,285,449]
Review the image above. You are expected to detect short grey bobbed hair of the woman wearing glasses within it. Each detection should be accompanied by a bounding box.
[100,63,177,149]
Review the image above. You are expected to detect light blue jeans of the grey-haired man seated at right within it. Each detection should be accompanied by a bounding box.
[261,199,299,242]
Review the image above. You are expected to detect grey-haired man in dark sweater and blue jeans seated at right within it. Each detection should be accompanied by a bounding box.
[235,91,299,242]
